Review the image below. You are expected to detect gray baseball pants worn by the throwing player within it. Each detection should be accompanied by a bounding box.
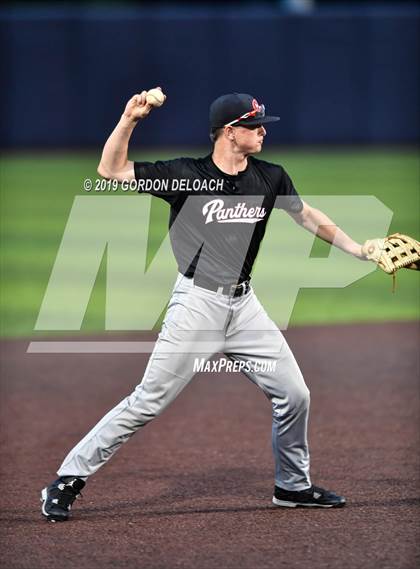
[58,275,311,490]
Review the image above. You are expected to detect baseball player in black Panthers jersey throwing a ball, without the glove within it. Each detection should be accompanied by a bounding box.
[41,89,365,521]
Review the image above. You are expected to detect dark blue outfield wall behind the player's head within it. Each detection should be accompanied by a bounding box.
[0,7,420,148]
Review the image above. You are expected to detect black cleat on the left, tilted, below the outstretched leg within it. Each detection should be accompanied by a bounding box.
[41,476,86,522]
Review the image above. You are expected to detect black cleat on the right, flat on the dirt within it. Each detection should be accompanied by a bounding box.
[273,486,346,508]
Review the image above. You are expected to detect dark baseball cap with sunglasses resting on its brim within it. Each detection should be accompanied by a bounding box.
[209,93,280,128]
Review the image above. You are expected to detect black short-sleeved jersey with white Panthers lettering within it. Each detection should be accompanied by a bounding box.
[134,155,303,284]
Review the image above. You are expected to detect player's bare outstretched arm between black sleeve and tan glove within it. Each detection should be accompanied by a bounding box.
[288,202,366,260]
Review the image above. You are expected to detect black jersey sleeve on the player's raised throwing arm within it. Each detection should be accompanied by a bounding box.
[134,158,184,203]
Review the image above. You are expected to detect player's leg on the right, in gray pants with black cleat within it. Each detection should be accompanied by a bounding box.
[225,293,345,507]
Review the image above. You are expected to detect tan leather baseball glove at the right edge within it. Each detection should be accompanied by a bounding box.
[362,233,420,291]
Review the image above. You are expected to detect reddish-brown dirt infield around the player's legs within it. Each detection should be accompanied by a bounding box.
[1,323,420,569]
